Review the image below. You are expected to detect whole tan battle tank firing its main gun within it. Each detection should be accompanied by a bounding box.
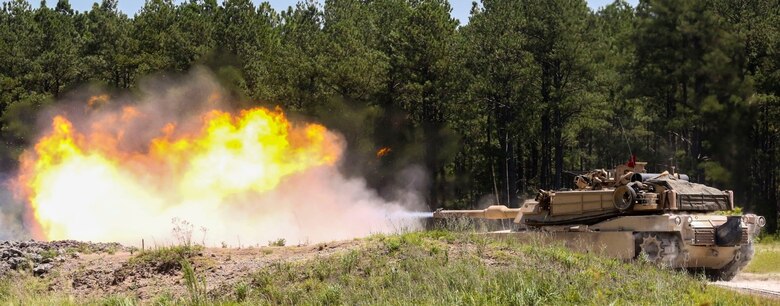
[433,162,766,280]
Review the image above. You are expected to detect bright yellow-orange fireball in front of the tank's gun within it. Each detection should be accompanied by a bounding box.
[17,107,342,241]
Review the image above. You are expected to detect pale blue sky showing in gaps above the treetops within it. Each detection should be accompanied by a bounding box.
[28,0,638,24]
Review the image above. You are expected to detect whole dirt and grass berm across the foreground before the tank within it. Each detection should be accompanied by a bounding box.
[0,231,778,305]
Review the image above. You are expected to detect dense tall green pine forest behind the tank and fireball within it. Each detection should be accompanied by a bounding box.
[0,0,780,231]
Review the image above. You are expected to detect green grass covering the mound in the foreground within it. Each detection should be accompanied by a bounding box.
[0,231,775,305]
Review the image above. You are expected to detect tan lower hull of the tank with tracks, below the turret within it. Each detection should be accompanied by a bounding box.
[438,213,761,280]
